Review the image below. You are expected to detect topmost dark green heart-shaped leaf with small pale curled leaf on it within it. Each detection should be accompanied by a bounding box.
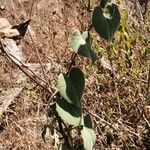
[92,3,121,40]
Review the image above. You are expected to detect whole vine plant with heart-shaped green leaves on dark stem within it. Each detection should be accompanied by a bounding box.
[42,0,120,150]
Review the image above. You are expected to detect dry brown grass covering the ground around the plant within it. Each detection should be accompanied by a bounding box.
[0,0,150,150]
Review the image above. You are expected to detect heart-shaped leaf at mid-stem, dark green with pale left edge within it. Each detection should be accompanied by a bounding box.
[58,68,85,107]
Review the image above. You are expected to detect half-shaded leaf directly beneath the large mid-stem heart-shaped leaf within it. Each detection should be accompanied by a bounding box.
[56,99,81,126]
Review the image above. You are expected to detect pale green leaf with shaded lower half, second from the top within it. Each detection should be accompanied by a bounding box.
[71,30,97,62]
